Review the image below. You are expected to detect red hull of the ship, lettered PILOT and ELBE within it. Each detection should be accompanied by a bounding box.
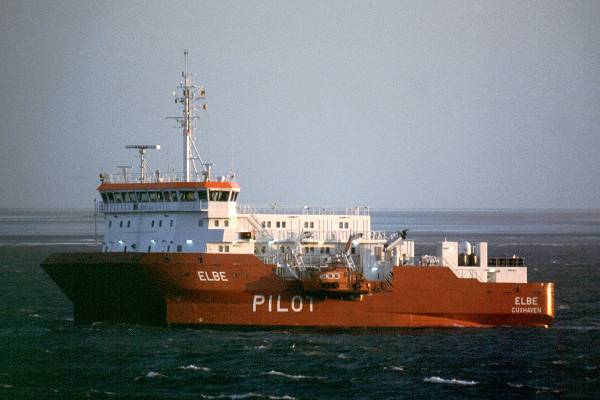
[43,253,554,328]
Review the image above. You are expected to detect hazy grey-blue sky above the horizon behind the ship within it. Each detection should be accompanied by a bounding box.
[0,0,600,208]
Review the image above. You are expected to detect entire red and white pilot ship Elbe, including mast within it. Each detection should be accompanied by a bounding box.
[42,52,554,328]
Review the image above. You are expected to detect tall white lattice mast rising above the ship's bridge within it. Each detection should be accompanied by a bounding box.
[166,50,210,182]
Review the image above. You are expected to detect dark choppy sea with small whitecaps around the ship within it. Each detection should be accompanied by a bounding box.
[0,210,600,399]
